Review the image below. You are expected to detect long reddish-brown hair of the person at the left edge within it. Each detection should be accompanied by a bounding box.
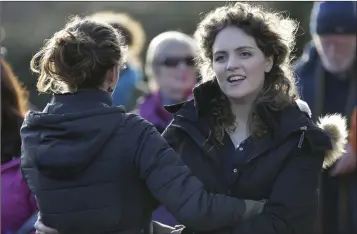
[0,58,29,163]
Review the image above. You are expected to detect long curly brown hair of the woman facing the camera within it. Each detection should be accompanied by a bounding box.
[194,3,298,143]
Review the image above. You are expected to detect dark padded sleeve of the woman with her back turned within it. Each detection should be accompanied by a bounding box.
[125,115,246,231]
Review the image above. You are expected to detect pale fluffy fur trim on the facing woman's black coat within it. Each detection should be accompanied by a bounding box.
[317,114,348,169]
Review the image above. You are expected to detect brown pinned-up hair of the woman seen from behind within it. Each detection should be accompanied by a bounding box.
[31,16,124,93]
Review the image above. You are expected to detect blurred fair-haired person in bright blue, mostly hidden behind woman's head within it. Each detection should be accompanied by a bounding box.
[90,11,146,110]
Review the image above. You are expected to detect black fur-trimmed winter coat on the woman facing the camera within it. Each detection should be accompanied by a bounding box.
[163,83,346,234]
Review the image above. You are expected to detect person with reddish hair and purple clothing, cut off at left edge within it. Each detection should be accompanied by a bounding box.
[0,58,37,234]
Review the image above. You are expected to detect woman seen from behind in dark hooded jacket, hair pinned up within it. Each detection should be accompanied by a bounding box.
[21,17,264,234]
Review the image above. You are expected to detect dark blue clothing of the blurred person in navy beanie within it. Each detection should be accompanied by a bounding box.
[295,42,357,234]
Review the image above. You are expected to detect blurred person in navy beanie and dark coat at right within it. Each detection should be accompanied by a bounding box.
[295,1,357,234]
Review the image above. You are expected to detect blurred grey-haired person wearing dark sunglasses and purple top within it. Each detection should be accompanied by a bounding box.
[136,31,197,132]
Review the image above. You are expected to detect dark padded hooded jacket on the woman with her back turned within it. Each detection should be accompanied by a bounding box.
[21,91,256,234]
